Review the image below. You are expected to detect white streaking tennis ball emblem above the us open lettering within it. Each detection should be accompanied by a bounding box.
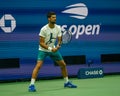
[62,3,88,19]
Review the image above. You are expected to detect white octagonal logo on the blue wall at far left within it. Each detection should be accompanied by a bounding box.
[0,14,16,33]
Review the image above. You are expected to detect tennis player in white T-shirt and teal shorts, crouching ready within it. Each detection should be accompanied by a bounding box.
[28,12,77,92]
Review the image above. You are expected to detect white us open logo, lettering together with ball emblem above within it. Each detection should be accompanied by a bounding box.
[61,3,101,39]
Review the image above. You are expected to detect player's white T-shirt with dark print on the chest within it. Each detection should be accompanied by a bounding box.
[39,24,62,52]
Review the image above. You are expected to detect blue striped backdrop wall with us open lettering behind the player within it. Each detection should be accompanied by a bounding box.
[0,0,120,79]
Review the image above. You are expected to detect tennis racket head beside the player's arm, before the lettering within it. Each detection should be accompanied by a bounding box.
[62,30,72,44]
